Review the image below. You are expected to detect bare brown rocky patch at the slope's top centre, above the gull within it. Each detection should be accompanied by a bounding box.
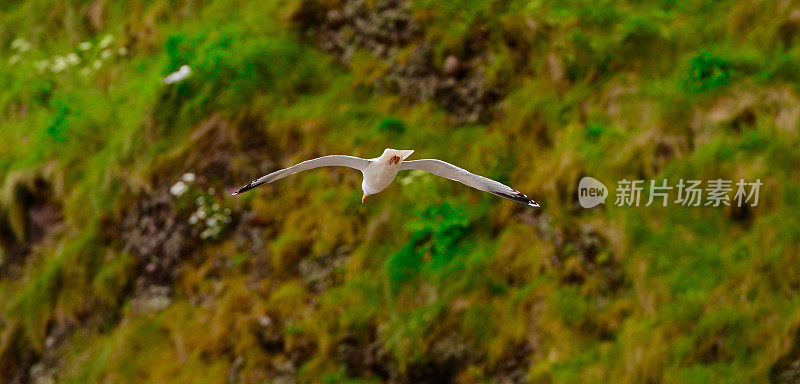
[292,0,501,123]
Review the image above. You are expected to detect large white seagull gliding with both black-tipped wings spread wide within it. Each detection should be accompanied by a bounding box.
[231,148,539,207]
